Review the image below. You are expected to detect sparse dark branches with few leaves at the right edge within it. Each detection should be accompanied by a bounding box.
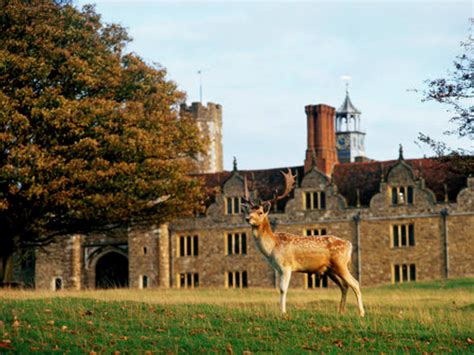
[418,19,474,156]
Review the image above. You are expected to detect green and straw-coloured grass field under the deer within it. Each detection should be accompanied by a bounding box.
[0,278,474,354]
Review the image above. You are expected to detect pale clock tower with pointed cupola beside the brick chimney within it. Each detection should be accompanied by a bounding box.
[336,90,365,163]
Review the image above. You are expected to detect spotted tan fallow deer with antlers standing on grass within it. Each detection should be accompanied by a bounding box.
[243,169,365,317]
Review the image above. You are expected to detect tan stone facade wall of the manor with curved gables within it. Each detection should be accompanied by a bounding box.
[36,160,474,289]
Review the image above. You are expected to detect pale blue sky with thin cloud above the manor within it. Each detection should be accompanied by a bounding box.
[74,0,474,170]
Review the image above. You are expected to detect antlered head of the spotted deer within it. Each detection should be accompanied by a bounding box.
[242,169,296,227]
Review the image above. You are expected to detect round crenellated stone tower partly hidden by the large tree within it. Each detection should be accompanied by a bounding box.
[181,102,224,173]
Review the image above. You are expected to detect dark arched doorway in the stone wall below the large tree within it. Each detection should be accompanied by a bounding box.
[95,252,128,288]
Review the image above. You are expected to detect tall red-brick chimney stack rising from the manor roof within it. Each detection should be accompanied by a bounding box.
[304,104,338,176]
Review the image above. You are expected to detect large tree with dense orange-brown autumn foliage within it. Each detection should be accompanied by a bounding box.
[0,0,202,283]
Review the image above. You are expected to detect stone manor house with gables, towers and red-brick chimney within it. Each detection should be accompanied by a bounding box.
[34,93,474,290]
